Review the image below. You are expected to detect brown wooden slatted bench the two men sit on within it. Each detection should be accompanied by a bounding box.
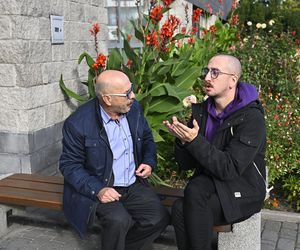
[0,174,232,235]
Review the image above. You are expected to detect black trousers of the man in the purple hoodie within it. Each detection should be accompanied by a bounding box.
[172,175,227,250]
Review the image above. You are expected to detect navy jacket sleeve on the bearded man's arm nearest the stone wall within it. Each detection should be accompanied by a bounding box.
[59,119,104,200]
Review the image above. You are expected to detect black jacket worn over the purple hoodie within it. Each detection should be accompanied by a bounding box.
[175,101,266,223]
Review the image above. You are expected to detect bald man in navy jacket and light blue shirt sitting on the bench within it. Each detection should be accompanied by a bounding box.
[59,70,169,250]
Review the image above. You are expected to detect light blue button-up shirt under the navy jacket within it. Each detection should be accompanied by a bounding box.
[100,106,136,187]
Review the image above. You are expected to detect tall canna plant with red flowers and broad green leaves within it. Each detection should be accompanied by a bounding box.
[60,0,238,184]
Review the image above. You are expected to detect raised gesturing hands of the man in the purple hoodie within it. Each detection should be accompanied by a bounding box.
[163,116,199,144]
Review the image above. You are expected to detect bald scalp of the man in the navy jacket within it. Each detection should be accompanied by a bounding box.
[95,70,130,99]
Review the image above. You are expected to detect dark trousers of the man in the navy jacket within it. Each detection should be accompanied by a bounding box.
[96,182,169,250]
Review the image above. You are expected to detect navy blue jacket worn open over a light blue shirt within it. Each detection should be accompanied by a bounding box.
[59,98,157,237]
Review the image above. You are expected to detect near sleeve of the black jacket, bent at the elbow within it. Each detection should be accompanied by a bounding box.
[185,108,266,180]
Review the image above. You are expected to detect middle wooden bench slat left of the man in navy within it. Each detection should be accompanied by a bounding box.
[0,178,63,194]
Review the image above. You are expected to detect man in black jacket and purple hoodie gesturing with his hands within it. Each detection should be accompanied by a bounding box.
[164,55,266,250]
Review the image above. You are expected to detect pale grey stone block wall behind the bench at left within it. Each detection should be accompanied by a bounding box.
[0,0,108,174]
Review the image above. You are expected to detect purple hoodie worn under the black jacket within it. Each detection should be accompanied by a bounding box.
[205,82,258,142]
